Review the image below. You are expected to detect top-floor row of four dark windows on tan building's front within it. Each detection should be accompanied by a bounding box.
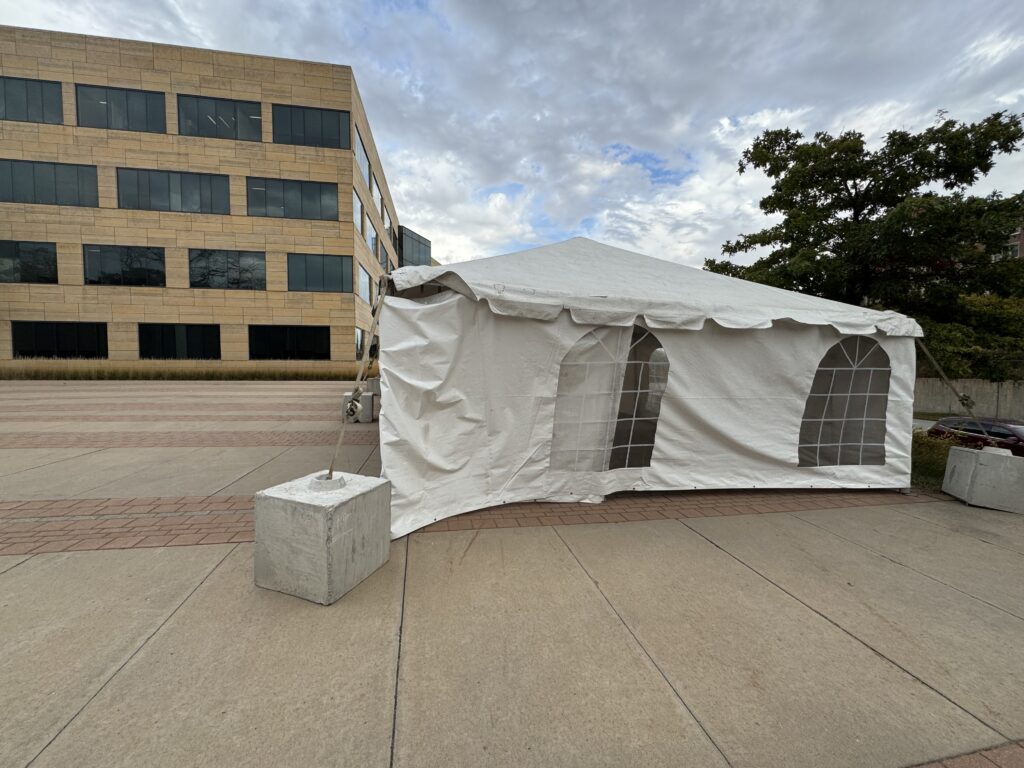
[0,77,348,154]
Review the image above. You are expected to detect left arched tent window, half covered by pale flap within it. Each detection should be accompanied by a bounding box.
[551,327,669,472]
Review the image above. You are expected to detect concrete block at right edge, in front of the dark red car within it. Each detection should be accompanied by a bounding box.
[942,447,1024,514]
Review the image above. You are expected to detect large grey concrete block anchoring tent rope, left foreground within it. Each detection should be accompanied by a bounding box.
[253,470,391,605]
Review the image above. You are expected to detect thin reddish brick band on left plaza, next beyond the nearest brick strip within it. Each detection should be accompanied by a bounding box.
[0,429,378,449]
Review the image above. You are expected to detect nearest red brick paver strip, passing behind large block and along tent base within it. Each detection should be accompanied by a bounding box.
[0,490,946,555]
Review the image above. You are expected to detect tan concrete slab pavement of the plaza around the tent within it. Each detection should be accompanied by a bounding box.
[0,382,1024,768]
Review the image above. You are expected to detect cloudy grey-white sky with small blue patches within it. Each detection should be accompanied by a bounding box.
[0,0,1024,265]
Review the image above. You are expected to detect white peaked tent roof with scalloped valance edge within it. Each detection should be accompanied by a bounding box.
[391,238,923,336]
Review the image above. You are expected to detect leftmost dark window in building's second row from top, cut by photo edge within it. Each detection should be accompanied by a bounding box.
[0,160,99,208]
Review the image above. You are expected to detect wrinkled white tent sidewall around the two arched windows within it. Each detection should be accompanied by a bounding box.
[381,293,914,537]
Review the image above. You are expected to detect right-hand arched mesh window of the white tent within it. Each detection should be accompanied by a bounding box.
[798,336,892,467]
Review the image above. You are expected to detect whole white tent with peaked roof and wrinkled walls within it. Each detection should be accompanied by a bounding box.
[380,238,922,537]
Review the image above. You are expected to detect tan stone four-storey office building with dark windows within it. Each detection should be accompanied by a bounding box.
[0,27,422,372]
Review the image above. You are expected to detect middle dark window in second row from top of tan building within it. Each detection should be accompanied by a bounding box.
[118,168,231,215]
